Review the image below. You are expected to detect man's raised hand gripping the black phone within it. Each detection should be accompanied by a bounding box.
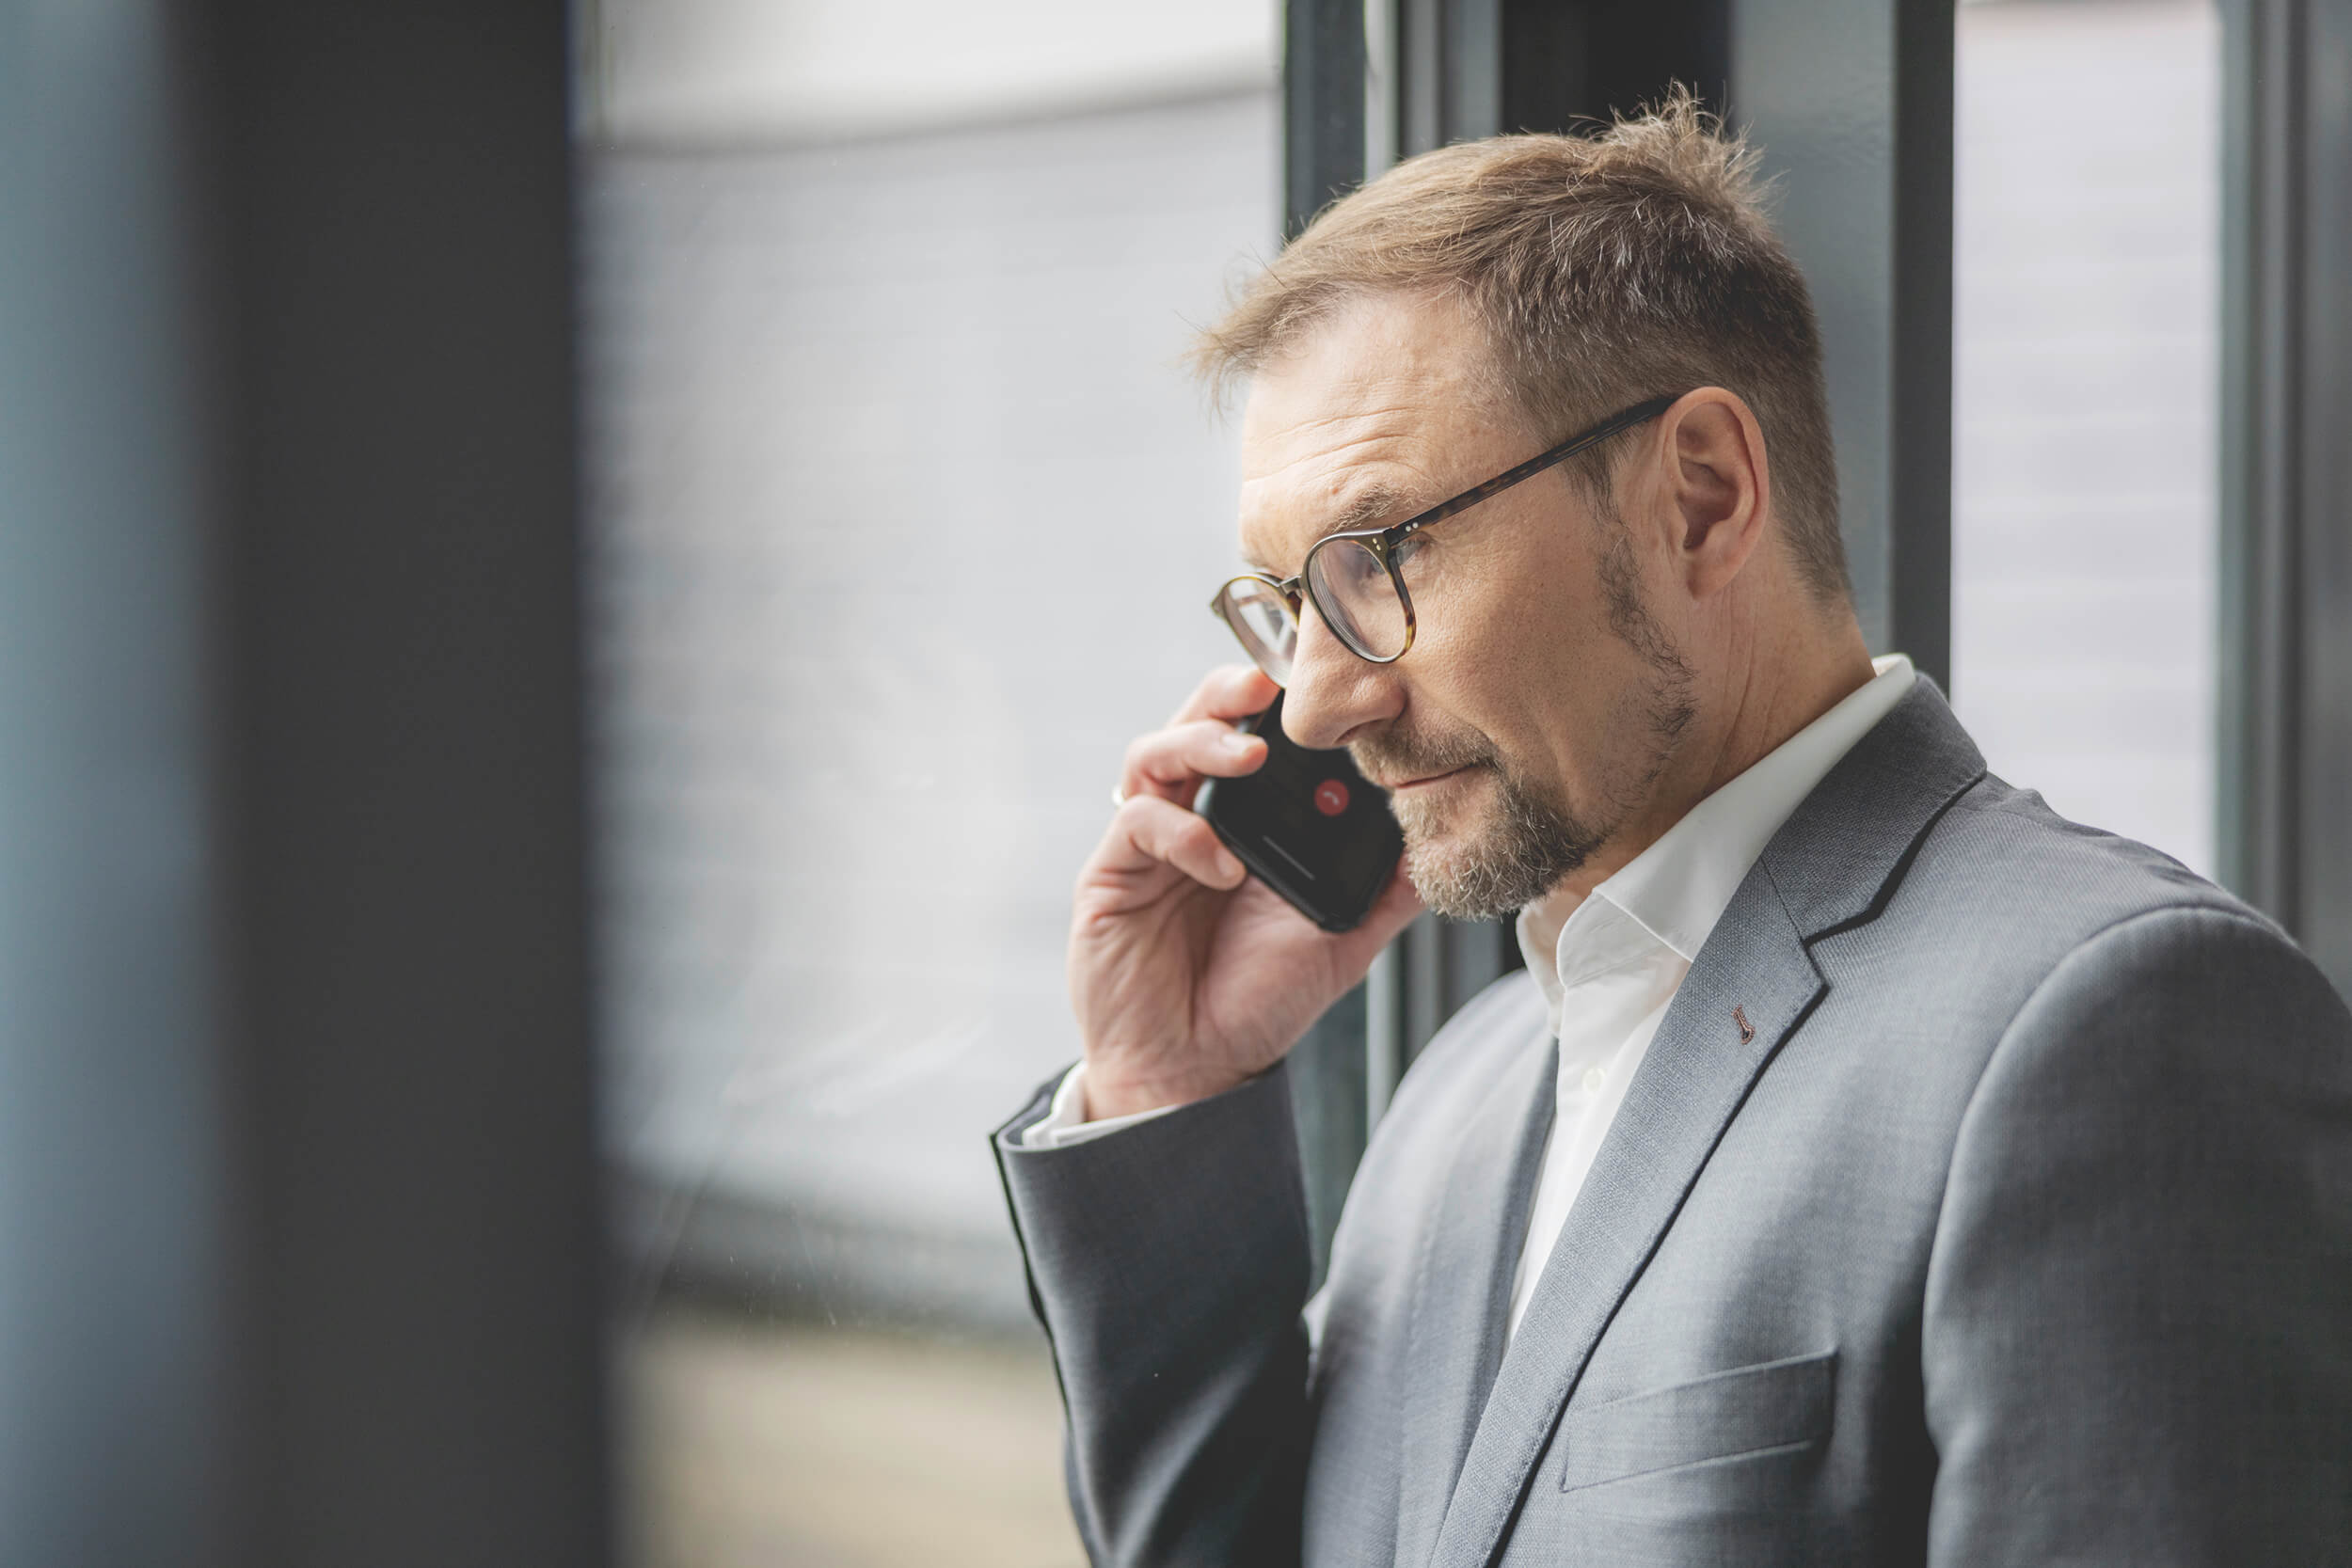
[1071,665,1421,1119]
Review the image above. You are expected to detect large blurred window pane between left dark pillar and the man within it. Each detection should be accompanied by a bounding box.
[581,0,1279,1568]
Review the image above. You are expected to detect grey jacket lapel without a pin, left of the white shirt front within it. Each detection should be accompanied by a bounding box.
[1397,1030,1560,1563]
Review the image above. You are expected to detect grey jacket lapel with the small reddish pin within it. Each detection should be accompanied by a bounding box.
[1400,677,1985,1568]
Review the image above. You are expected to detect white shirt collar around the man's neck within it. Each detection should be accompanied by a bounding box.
[1518,654,1913,1035]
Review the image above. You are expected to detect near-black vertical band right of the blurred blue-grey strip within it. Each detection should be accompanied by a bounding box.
[207,0,605,1568]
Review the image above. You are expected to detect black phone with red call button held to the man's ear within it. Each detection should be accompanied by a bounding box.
[1193,696,1405,931]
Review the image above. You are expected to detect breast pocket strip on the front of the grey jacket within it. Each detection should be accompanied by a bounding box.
[1560,1350,1837,1491]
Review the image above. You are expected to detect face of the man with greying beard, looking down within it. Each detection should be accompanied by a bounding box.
[1240,296,1692,919]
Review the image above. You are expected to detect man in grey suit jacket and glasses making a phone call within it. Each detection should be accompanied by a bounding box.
[997,99,2352,1568]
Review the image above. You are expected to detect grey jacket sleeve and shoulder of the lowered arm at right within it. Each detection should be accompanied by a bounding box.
[1922,908,2352,1568]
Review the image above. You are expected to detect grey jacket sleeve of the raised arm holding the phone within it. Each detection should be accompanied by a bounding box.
[995,1068,1311,1568]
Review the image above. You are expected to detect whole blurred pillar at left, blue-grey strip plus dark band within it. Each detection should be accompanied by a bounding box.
[0,0,607,1568]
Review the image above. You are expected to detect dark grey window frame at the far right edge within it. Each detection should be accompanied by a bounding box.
[2218,0,2352,994]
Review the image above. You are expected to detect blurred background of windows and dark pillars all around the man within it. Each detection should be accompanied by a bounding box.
[0,0,2352,1568]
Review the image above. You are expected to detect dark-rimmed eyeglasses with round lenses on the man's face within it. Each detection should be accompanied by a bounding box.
[1209,392,1682,687]
